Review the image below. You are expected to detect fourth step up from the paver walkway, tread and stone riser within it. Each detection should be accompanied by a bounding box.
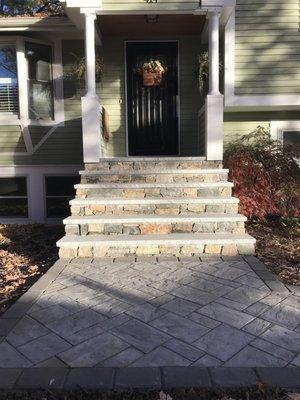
[75,182,233,198]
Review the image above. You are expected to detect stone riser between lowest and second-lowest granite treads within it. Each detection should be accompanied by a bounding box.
[65,221,245,236]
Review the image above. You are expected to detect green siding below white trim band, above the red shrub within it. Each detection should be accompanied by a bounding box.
[224,111,299,148]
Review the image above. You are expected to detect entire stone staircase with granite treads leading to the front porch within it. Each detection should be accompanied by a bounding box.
[57,157,255,258]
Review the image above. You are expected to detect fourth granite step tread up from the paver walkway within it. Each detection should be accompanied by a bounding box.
[75,181,234,189]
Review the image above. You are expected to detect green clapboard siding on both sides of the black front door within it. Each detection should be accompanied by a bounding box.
[99,36,203,157]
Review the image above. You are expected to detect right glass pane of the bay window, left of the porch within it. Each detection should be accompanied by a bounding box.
[25,42,54,120]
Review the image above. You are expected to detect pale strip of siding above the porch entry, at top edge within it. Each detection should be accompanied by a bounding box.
[102,0,199,14]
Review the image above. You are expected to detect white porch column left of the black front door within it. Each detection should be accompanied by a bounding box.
[81,9,101,163]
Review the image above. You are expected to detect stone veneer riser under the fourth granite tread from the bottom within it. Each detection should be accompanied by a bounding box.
[76,185,232,199]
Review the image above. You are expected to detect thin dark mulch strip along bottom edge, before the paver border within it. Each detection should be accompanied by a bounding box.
[0,385,300,400]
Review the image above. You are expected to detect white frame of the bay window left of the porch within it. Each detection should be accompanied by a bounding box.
[0,36,64,126]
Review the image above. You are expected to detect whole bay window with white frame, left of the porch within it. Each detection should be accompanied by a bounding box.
[0,36,63,125]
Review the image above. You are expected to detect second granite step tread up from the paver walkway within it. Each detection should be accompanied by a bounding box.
[63,213,247,225]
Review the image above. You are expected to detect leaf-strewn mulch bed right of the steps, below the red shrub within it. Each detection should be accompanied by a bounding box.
[247,218,300,286]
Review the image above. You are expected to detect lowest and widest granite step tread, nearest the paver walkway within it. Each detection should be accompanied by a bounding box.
[57,233,255,247]
